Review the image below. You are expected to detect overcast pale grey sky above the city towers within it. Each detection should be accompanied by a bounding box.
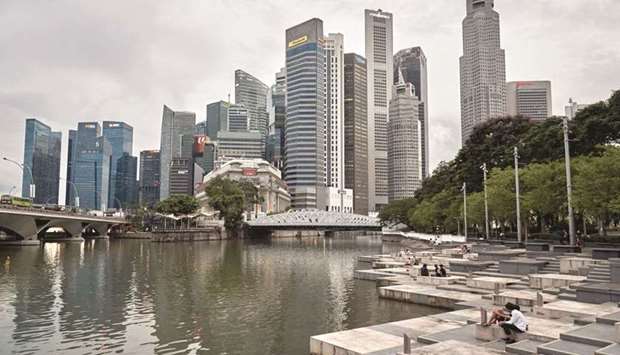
[0,0,620,202]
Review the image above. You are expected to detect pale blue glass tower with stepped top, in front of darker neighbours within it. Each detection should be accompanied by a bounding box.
[72,136,112,211]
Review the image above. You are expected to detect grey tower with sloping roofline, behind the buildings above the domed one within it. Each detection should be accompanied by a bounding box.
[235,69,269,139]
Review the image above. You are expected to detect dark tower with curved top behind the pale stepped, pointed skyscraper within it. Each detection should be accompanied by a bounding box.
[394,47,430,179]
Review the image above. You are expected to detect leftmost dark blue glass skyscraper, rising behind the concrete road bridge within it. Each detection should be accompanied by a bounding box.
[22,118,61,204]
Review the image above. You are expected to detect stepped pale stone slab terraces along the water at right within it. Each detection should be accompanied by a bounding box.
[309,243,620,355]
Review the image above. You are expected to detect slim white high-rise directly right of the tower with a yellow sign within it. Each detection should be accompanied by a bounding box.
[324,33,353,212]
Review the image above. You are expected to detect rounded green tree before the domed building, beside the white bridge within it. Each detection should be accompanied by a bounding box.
[205,177,246,231]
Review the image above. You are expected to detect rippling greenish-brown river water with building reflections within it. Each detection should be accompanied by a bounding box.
[0,237,436,354]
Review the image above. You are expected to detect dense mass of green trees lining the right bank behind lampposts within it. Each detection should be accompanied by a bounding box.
[379,91,620,235]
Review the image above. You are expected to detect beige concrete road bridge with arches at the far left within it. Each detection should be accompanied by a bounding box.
[0,206,129,245]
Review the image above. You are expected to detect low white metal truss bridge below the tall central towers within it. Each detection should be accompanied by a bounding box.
[247,209,381,236]
